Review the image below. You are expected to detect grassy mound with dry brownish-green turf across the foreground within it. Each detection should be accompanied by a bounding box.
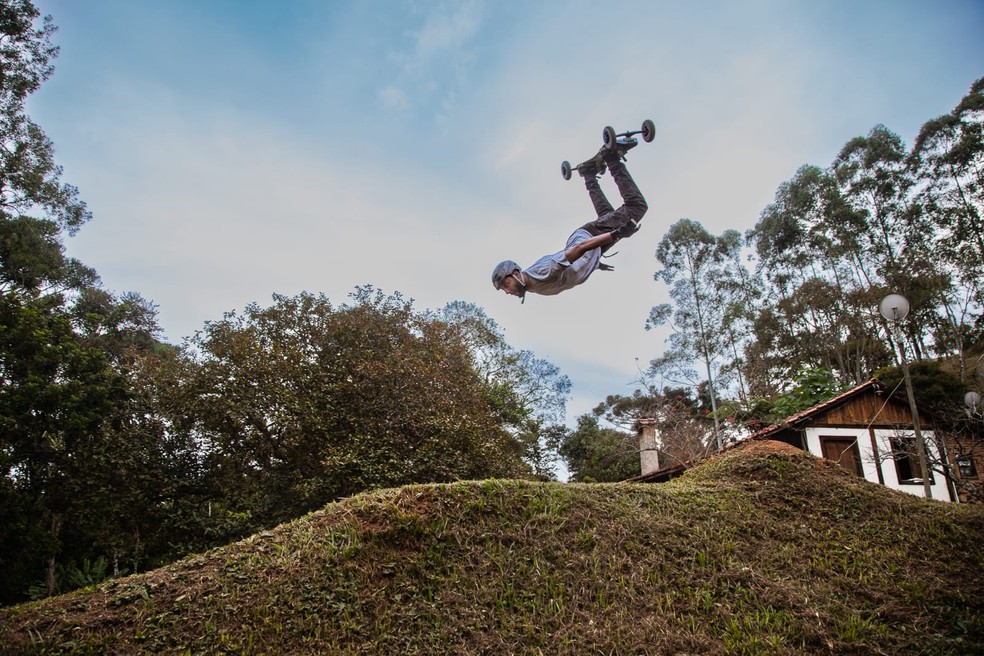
[0,443,984,655]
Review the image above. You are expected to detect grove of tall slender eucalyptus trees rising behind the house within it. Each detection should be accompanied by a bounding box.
[647,78,984,418]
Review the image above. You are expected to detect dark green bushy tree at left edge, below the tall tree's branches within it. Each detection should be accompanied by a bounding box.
[0,295,120,604]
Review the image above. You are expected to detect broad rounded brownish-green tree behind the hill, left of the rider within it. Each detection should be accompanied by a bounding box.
[172,288,528,531]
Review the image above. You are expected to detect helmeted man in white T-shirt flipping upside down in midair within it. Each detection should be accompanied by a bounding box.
[492,140,648,302]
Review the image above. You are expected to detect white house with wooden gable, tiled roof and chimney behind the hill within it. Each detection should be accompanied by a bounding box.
[632,379,984,501]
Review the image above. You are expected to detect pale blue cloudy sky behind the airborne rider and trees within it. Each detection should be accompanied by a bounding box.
[29,0,984,428]
